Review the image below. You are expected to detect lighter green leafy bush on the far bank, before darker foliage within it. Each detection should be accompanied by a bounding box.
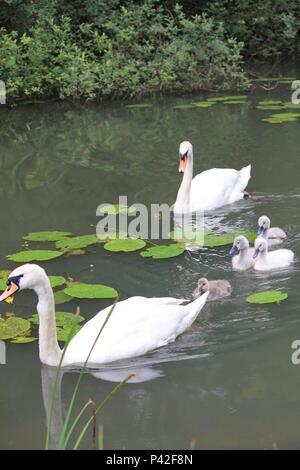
[0,0,248,100]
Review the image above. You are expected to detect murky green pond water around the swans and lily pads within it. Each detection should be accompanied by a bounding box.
[0,85,300,449]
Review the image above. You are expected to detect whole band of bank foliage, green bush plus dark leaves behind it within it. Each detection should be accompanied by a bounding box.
[0,0,299,100]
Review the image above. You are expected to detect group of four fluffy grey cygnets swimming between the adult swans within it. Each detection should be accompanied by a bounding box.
[193,215,294,301]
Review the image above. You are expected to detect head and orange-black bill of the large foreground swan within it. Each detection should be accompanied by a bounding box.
[0,264,49,302]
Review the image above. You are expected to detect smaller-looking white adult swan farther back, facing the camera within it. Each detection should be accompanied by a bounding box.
[174,141,251,213]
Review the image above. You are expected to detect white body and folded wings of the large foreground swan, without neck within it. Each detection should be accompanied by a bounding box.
[63,294,207,365]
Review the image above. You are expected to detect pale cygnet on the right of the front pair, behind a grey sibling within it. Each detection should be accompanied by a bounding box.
[253,237,294,271]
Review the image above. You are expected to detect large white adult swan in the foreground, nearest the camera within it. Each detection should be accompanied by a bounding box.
[0,264,208,366]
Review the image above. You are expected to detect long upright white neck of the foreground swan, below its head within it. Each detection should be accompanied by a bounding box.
[35,278,62,366]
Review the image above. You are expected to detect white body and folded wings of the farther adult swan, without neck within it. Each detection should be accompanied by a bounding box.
[190,165,251,211]
